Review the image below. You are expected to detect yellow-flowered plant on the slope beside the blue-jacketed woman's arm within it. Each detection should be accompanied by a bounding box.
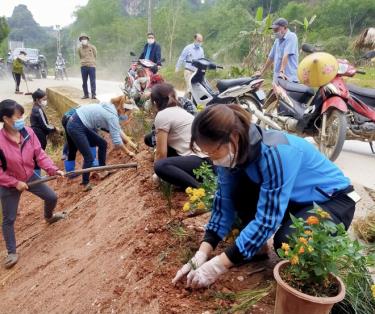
[182,162,217,215]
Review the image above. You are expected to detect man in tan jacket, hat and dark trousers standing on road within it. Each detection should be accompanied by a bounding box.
[78,33,96,99]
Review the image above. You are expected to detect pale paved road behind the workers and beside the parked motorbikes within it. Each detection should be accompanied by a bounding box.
[0,78,375,190]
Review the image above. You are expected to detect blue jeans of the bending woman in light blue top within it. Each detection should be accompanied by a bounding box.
[66,113,107,184]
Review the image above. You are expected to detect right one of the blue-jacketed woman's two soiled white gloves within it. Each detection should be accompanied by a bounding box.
[187,256,228,288]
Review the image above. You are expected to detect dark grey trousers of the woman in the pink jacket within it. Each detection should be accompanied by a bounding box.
[0,174,57,254]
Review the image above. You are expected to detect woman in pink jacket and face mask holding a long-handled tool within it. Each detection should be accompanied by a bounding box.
[0,99,65,268]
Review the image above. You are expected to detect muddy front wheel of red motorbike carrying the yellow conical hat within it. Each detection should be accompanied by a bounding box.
[314,109,348,161]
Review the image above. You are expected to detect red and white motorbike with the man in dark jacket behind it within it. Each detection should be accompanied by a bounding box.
[122,52,165,95]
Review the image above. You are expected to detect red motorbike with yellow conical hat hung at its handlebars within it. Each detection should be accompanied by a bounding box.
[262,44,375,161]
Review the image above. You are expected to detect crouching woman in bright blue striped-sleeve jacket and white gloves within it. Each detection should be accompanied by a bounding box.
[172,104,357,288]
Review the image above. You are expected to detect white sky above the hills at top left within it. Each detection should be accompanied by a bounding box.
[0,0,88,26]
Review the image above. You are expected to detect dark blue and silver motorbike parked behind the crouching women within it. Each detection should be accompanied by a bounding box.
[186,58,279,128]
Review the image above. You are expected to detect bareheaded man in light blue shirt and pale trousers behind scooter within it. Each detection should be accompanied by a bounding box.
[176,34,204,92]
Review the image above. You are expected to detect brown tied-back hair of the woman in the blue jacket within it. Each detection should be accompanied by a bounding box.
[190,104,251,164]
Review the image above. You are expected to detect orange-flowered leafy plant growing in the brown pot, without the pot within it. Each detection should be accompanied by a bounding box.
[277,205,358,297]
